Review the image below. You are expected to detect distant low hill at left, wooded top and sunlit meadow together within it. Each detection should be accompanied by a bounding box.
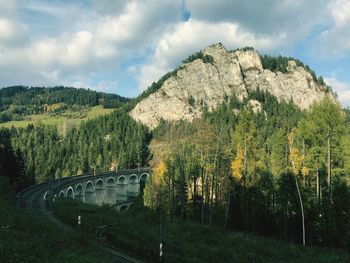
[0,86,130,127]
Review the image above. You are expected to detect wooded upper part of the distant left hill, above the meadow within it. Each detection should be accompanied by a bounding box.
[0,86,129,123]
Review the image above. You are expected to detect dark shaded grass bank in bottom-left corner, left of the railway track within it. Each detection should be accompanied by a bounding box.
[0,176,111,263]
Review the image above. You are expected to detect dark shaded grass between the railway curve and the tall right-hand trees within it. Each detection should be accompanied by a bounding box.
[50,200,350,263]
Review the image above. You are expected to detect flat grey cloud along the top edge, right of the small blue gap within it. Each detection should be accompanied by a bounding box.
[185,0,325,38]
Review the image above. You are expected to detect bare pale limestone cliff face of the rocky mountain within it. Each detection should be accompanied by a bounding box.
[130,44,328,128]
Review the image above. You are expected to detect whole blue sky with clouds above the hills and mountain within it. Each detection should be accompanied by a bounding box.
[0,0,350,107]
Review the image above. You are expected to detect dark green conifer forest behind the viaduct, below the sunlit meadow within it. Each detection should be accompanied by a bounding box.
[0,109,151,184]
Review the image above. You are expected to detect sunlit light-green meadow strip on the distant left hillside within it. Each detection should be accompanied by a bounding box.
[0,105,114,128]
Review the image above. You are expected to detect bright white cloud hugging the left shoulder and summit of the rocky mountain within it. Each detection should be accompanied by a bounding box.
[139,19,285,89]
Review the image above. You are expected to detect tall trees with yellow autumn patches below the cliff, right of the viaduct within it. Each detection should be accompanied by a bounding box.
[145,90,350,252]
